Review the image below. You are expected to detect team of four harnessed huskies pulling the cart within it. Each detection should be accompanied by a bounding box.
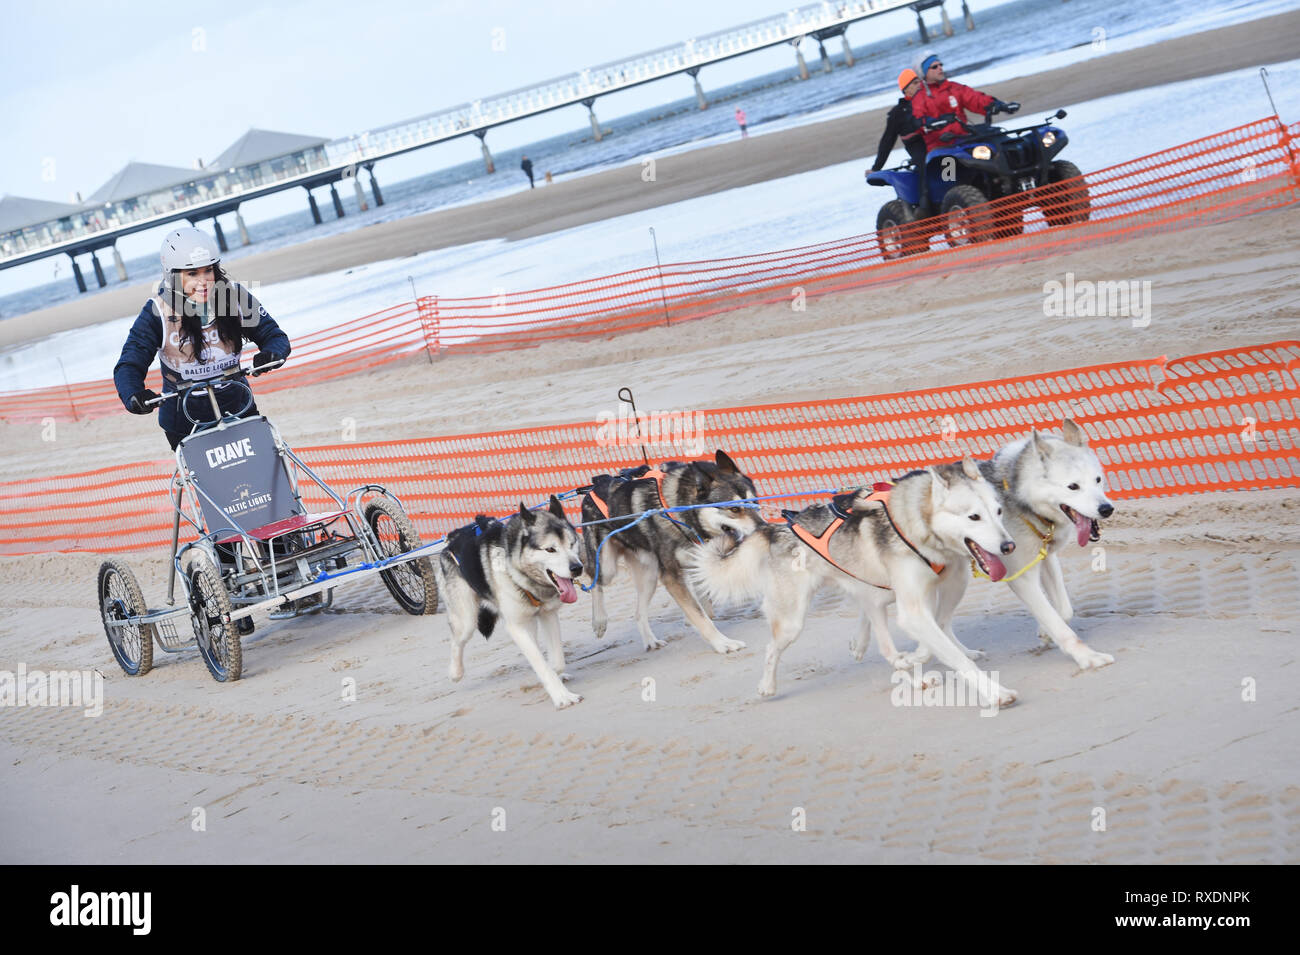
[439,418,1114,707]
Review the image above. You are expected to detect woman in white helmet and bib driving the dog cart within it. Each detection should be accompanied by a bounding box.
[113,227,290,451]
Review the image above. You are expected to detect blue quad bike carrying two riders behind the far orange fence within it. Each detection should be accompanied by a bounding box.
[866,101,1092,259]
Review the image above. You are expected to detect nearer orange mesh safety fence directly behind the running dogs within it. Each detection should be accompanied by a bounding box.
[0,340,1300,555]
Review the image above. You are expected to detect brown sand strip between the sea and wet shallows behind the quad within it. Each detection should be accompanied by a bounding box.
[0,5,1300,348]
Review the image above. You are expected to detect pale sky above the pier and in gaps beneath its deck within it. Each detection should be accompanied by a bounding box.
[0,0,967,201]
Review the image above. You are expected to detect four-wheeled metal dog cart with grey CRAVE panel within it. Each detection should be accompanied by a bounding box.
[98,366,441,682]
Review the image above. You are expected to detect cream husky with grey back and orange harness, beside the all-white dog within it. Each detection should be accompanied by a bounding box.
[690,457,1017,707]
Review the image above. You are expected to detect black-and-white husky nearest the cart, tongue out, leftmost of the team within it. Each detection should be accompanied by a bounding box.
[438,495,582,709]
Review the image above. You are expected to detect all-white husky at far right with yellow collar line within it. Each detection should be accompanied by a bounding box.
[904,418,1115,669]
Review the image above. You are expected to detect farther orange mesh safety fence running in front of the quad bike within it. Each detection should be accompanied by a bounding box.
[0,117,1300,421]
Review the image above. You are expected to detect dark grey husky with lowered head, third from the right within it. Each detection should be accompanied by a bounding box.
[582,450,766,654]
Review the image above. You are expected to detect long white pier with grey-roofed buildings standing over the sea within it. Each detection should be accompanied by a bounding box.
[0,0,975,291]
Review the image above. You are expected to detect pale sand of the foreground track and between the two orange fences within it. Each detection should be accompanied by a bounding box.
[0,191,1300,864]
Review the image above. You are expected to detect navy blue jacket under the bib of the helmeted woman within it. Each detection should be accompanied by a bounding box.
[113,285,290,434]
